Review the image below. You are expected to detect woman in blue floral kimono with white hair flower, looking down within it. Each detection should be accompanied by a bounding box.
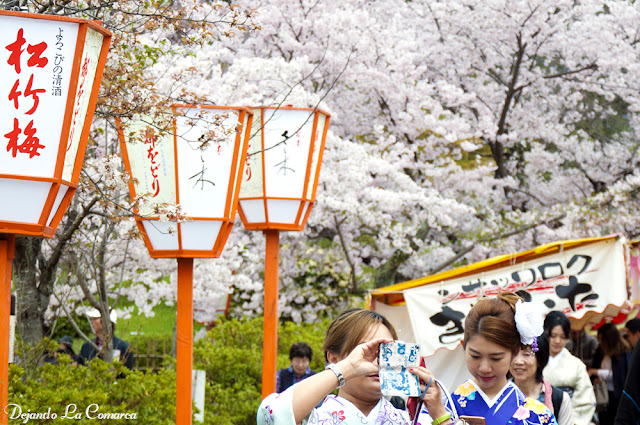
[414,292,557,425]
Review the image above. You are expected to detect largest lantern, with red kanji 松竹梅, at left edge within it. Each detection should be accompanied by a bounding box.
[0,11,111,236]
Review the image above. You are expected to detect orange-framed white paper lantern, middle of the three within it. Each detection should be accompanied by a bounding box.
[120,105,253,258]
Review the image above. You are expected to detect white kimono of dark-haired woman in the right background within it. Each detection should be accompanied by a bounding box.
[542,348,596,425]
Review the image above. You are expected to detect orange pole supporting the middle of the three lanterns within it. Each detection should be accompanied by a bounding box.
[176,258,193,425]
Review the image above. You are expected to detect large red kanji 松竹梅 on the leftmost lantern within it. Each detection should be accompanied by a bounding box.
[4,28,49,158]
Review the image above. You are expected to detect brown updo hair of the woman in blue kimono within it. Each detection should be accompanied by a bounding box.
[464,292,522,356]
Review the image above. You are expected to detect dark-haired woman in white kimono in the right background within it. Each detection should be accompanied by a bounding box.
[542,311,596,425]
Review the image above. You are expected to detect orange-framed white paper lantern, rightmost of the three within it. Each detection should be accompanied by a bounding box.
[239,106,330,230]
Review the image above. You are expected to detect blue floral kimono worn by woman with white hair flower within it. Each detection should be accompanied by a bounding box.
[418,380,558,425]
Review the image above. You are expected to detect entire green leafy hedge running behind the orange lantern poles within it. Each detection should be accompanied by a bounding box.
[9,317,328,425]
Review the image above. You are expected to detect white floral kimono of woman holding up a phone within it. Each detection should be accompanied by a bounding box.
[256,385,410,425]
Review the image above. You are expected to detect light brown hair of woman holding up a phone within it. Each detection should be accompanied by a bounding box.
[322,308,398,362]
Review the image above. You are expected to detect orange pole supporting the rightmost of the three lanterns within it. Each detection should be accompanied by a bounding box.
[262,230,280,399]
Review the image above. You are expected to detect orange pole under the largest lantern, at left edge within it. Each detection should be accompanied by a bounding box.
[0,235,15,425]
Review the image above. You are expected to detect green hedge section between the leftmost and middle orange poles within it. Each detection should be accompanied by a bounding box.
[8,355,175,425]
